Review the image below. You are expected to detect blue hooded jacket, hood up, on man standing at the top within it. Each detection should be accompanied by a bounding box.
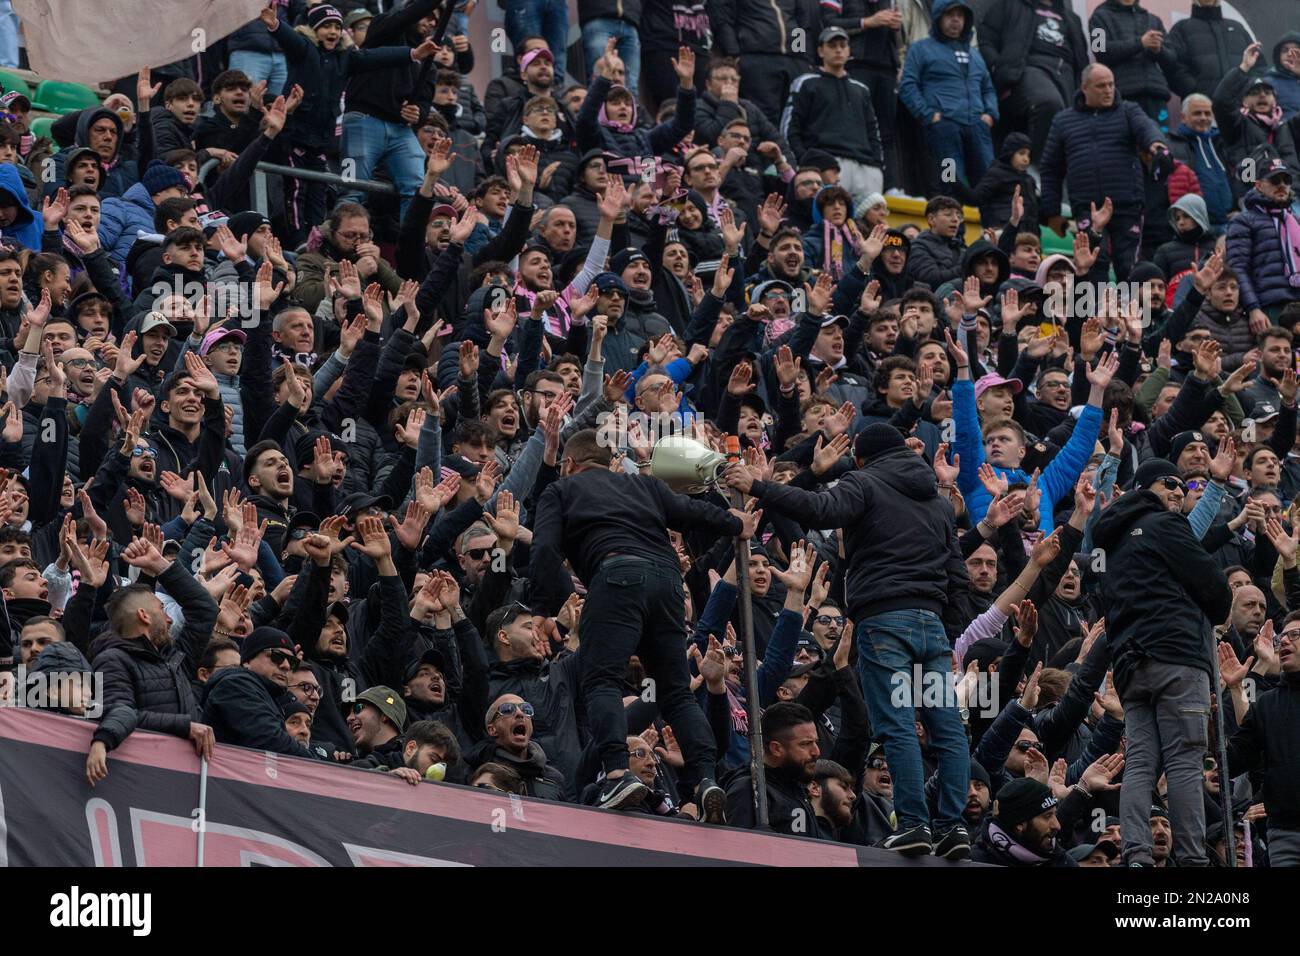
[898,0,997,126]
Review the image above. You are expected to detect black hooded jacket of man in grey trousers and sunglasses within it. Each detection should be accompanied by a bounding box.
[1092,492,1232,692]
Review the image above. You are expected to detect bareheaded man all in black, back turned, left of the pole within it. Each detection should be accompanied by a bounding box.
[530,429,762,823]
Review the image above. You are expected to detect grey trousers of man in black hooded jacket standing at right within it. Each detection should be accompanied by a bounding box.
[1119,659,1210,866]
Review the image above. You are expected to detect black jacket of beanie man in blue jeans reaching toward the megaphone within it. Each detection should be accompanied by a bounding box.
[751,449,970,635]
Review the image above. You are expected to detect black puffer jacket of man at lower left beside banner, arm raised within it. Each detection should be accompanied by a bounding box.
[90,562,217,737]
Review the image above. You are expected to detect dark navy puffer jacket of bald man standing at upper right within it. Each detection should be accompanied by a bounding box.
[1040,90,1160,217]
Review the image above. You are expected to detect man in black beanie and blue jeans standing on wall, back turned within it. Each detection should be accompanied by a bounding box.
[725,423,970,860]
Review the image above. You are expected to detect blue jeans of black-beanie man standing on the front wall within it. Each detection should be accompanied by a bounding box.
[854,610,971,832]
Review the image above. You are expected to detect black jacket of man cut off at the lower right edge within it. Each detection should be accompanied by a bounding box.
[1227,674,1300,830]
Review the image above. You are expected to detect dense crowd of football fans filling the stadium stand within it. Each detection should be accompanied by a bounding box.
[0,0,1300,866]
